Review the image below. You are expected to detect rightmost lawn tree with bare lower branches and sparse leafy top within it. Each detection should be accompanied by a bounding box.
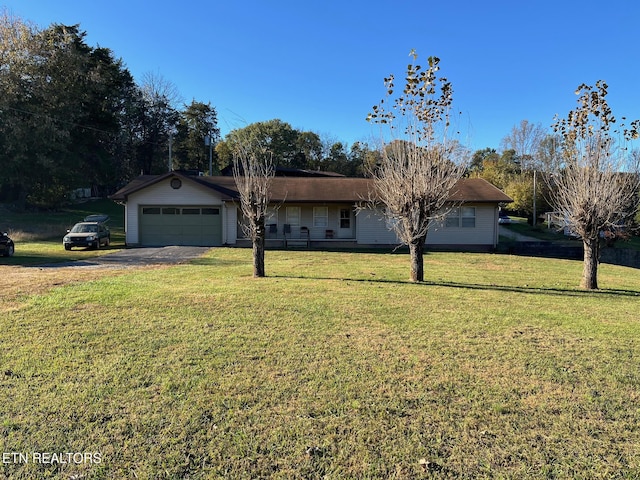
[550,80,640,289]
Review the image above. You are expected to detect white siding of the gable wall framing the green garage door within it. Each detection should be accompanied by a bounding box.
[125,177,225,245]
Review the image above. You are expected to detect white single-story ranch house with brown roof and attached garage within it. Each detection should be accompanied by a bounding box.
[109,171,512,250]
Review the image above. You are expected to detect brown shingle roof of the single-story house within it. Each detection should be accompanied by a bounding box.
[109,172,513,203]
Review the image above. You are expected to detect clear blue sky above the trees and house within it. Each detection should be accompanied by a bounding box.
[5,0,640,150]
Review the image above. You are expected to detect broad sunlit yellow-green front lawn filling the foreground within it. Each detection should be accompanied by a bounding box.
[0,248,640,479]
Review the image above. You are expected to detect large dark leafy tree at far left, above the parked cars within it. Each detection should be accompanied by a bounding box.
[0,13,140,207]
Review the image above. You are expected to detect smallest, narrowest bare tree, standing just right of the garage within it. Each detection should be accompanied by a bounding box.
[233,143,275,277]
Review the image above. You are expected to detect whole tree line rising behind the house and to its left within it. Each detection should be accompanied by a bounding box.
[0,11,384,208]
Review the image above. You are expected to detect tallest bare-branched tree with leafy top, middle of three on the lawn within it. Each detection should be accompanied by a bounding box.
[367,51,465,282]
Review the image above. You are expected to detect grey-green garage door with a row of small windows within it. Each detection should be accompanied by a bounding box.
[138,205,222,246]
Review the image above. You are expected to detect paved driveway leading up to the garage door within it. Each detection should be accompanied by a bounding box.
[38,246,211,268]
